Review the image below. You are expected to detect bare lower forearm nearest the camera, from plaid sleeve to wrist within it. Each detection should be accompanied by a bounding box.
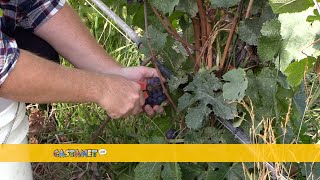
[0,50,104,103]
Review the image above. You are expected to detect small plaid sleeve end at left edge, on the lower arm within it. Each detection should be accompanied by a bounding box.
[0,37,20,85]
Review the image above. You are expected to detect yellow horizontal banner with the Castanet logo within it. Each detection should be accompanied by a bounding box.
[0,144,320,162]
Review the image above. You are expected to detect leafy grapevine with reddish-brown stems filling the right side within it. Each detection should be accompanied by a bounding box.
[80,0,320,179]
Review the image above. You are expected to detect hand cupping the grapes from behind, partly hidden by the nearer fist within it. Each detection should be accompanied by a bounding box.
[119,66,168,117]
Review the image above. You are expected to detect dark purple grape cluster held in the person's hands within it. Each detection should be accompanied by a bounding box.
[146,77,167,106]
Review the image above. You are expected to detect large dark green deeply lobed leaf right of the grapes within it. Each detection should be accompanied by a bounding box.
[178,70,237,129]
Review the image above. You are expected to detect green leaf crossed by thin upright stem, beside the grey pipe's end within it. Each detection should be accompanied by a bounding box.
[141,25,168,55]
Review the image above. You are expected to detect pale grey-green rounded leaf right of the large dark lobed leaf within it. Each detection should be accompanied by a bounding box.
[223,68,248,101]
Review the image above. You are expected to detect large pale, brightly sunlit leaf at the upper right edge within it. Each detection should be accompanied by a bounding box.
[276,8,320,72]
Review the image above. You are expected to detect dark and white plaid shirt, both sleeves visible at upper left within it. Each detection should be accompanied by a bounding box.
[0,0,65,85]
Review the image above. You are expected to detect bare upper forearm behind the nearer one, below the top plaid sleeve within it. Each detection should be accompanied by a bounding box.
[35,4,120,73]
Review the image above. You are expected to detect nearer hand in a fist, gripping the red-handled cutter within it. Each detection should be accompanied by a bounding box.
[98,75,145,119]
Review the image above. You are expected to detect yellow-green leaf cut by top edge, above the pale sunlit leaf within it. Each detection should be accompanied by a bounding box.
[269,0,314,14]
